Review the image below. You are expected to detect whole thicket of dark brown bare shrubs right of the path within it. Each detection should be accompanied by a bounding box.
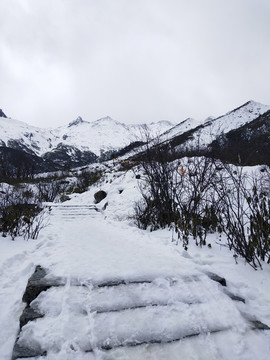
[135,134,270,269]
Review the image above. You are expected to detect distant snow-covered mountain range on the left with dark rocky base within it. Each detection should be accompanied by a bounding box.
[0,112,174,169]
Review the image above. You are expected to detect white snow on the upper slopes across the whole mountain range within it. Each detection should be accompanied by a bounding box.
[0,101,270,156]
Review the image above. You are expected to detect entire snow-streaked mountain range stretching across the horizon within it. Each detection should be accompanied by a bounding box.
[0,100,270,178]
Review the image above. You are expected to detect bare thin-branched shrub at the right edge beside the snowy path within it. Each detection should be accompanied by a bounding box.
[215,164,270,269]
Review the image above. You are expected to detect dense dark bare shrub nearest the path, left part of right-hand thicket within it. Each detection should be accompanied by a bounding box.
[134,131,217,246]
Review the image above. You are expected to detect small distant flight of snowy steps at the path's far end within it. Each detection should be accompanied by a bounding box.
[48,204,98,221]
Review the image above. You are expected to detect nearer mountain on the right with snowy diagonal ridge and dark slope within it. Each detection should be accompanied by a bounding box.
[133,100,270,165]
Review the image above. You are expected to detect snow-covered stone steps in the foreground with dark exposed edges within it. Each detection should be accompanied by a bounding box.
[12,267,266,359]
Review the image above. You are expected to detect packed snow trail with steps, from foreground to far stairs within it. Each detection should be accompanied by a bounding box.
[3,205,270,360]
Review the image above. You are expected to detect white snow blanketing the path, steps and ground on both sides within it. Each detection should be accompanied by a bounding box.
[0,170,270,360]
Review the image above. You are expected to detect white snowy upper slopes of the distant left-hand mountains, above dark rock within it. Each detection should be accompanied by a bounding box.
[0,117,173,156]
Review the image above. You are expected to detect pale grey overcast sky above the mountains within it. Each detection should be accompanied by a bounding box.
[0,0,270,127]
